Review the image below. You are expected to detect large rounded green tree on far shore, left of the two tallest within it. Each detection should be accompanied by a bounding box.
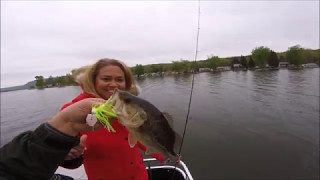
[251,46,270,67]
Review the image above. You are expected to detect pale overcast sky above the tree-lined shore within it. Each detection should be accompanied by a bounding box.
[1,1,319,88]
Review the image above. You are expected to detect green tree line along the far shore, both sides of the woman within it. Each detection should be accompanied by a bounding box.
[35,45,320,88]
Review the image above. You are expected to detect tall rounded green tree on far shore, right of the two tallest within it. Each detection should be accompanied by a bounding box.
[286,45,305,66]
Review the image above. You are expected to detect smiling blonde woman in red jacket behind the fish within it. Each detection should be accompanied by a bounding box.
[61,59,163,180]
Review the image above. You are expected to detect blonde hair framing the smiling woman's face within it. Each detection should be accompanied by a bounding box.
[76,58,139,98]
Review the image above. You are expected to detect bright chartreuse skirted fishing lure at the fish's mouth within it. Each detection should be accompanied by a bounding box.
[92,96,118,132]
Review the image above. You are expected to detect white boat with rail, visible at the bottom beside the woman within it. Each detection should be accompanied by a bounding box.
[56,158,193,180]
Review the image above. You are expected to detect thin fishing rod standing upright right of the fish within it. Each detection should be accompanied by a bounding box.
[172,0,200,179]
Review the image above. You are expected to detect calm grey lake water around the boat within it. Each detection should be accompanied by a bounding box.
[1,68,319,179]
